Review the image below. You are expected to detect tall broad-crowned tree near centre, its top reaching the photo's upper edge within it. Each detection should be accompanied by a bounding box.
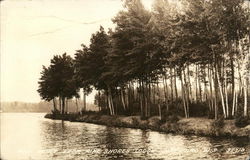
[111,0,166,118]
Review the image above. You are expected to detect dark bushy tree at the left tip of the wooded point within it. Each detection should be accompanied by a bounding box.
[38,53,78,114]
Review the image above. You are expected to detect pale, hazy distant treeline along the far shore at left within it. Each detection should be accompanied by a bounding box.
[1,101,98,113]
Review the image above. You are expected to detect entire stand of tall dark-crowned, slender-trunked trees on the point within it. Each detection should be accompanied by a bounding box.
[38,0,250,119]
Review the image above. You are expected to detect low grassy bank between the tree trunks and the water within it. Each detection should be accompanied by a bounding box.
[44,113,250,139]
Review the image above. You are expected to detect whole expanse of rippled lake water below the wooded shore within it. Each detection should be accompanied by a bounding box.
[1,113,250,160]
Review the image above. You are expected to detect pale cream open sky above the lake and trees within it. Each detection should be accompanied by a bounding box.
[0,0,152,103]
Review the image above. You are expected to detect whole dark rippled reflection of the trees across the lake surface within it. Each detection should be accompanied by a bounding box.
[41,121,250,159]
